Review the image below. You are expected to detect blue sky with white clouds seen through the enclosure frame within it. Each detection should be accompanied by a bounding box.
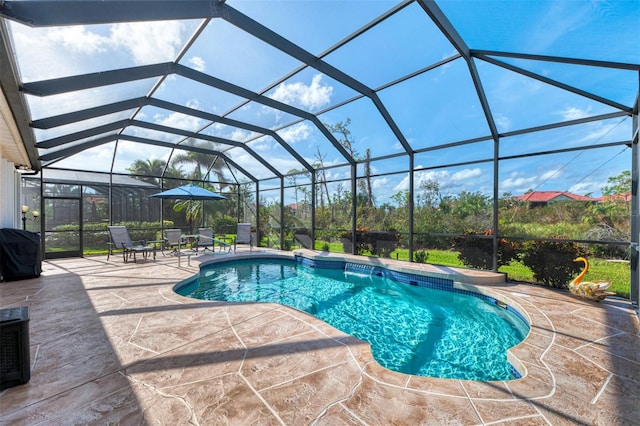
[10,0,640,204]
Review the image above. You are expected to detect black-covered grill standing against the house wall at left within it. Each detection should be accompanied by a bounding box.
[0,228,42,281]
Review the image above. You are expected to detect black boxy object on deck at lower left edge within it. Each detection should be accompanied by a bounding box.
[0,306,31,390]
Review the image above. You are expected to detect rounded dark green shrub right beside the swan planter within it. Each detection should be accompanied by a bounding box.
[522,237,586,288]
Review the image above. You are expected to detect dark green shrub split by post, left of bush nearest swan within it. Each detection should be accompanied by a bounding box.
[453,230,517,269]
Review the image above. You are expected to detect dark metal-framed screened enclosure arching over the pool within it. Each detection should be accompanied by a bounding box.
[0,0,640,302]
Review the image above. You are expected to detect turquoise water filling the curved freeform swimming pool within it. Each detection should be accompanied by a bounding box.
[176,259,528,380]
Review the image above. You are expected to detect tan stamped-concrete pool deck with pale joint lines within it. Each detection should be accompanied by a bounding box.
[0,249,640,426]
